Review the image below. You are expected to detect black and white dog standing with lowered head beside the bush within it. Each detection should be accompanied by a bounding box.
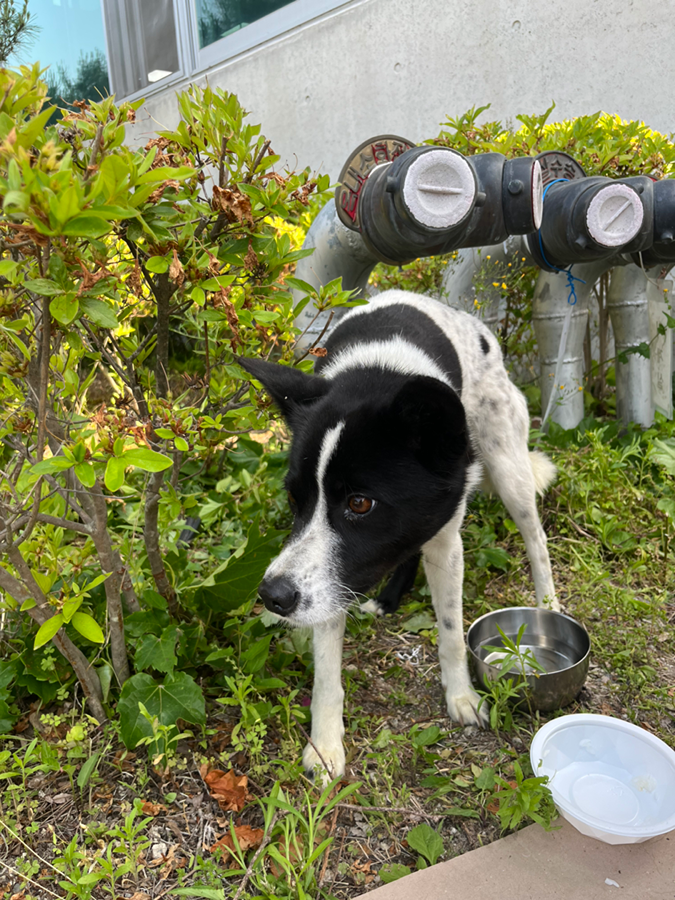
[241,291,558,778]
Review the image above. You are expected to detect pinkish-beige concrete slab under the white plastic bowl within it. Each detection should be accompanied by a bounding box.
[367,819,675,900]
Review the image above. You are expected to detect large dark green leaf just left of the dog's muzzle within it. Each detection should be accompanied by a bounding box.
[197,519,286,613]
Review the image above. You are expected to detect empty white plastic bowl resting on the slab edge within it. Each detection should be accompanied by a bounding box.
[530,714,675,844]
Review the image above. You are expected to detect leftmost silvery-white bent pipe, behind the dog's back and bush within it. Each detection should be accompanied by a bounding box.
[293,200,378,356]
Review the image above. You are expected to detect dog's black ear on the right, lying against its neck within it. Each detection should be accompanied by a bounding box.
[393,375,469,475]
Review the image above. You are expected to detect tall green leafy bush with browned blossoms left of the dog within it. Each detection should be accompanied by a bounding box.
[0,65,360,740]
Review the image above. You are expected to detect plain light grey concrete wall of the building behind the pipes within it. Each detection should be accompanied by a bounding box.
[129,0,675,179]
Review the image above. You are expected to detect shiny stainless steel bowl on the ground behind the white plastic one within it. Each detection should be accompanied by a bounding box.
[466,606,591,711]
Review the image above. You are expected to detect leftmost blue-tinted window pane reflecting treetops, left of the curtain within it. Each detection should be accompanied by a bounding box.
[26,0,109,102]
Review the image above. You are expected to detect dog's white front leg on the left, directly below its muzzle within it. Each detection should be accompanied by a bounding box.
[302,613,347,782]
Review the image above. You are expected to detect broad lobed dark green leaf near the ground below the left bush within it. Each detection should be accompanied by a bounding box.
[117,672,206,750]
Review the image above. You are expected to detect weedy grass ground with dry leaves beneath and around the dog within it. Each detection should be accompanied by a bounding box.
[0,421,675,900]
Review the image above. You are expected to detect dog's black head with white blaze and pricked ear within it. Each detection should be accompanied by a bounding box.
[240,359,470,625]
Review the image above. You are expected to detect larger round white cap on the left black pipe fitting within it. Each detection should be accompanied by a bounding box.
[403,148,476,228]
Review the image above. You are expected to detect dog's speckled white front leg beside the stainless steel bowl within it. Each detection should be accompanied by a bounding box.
[422,510,488,725]
